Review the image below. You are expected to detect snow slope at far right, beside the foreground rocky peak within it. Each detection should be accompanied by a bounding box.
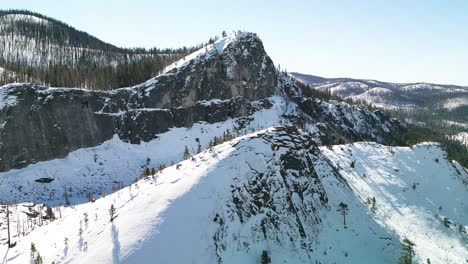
[321,143,468,263]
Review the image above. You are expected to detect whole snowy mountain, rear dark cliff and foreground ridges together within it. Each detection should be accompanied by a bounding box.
[0,28,468,263]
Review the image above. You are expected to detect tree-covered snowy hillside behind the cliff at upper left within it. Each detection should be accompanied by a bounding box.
[0,10,218,90]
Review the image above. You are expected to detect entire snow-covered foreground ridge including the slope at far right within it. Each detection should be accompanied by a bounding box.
[0,126,468,263]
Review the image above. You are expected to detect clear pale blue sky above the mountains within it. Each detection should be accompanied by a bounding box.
[0,0,468,85]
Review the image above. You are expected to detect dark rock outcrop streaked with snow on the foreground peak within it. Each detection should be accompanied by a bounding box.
[214,126,328,262]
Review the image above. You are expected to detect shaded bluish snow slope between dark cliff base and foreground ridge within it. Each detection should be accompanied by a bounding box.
[0,96,286,205]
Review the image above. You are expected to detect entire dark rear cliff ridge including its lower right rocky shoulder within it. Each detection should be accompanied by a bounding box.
[0,32,401,172]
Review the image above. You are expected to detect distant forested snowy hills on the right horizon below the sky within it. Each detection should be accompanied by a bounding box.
[290,72,468,127]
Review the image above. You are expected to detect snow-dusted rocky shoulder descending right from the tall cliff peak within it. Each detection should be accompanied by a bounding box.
[278,74,407,145]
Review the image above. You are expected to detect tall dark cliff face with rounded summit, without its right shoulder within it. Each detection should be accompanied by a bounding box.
[0,33,277,171]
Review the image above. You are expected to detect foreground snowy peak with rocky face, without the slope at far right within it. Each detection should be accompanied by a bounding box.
[0,127,399,263]
